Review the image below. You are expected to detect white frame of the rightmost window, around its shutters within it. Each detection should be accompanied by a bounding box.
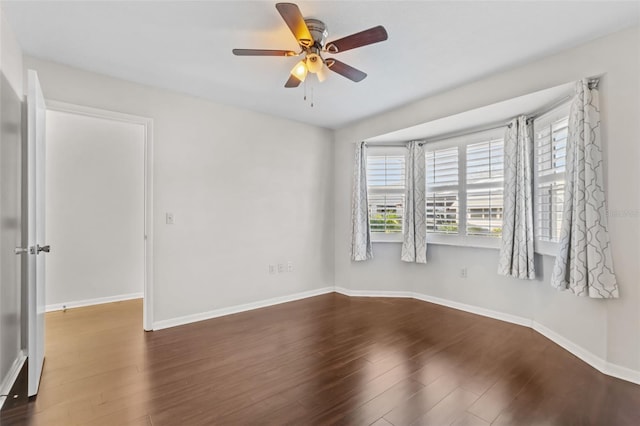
[533,99,571,256]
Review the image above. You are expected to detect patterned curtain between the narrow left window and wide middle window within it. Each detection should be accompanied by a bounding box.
[401,141,427,263]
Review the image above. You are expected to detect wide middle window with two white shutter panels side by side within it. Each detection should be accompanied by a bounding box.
[425,128,504,247]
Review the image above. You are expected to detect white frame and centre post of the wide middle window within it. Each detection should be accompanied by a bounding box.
[425,125,506,249]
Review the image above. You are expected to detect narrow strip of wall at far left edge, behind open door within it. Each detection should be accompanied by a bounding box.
[0,5,23,400]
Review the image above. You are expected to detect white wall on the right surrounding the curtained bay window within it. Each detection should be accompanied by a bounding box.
[334,28,640,377]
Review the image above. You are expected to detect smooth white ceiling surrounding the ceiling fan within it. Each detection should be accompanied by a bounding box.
[0,0,640,128]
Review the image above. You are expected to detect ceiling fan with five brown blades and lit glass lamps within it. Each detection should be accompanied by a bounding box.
[233,3,387,87]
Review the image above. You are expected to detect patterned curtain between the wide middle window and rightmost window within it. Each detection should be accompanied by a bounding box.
[498,116,536,280]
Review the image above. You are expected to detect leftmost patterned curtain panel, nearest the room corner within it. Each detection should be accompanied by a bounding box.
[351,142,373,261]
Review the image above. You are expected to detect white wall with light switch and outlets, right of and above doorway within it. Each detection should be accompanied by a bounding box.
[25,57,333,322]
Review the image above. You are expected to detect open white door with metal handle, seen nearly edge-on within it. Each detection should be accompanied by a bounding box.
[27,70,49,396]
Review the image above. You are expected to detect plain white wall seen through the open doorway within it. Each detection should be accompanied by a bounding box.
[45,110,145,308]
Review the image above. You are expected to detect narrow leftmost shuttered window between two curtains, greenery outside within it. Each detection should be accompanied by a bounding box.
[367,147,405,241]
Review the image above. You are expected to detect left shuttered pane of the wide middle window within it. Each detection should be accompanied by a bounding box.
[425,146,460,234]
